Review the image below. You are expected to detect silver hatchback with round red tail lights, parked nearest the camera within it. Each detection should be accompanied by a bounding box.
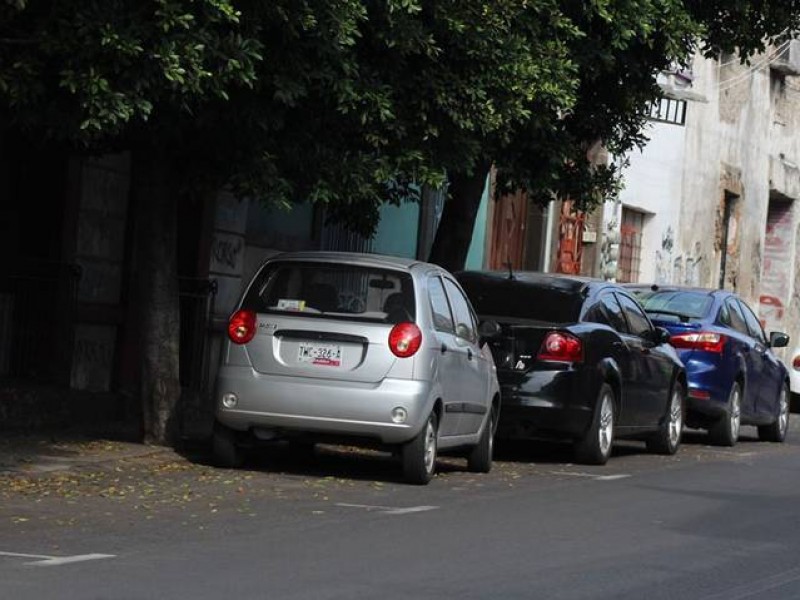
[213,252,500,484]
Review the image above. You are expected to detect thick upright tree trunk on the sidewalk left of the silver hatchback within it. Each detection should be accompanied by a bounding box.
[132,148,180,445]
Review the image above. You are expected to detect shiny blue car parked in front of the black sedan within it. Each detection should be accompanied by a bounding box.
[626,285,789,446]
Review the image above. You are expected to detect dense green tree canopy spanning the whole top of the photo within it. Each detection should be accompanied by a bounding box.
[0,0,800,233]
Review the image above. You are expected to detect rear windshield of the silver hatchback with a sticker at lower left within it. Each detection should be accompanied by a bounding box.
[242,262,416,323]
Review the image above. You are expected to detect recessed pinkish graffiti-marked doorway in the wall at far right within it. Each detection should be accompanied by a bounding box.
[758,200,793,331]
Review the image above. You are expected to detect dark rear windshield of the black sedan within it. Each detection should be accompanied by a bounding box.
[460,278,583,323]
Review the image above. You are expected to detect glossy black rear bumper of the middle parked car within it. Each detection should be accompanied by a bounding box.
[497,371,595,439]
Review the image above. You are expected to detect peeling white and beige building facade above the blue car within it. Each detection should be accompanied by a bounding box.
[616,48,800,360]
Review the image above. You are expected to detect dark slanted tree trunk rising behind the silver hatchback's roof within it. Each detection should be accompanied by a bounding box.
[428,164,491,271]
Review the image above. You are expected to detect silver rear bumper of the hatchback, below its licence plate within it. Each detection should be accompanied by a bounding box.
[214,366,433,444]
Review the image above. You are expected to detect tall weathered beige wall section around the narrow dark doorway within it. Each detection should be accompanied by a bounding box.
[676,53,771,300]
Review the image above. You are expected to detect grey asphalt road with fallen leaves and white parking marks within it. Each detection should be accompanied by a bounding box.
[0,422,800,600]
